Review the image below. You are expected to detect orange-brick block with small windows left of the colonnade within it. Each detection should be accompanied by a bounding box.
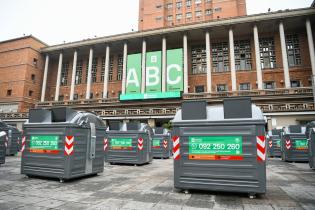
[0,36,47,113]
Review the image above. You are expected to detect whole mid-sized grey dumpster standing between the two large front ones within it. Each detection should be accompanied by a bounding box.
[105,122,153,165]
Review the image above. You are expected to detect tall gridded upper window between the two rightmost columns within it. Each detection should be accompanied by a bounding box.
[286,34,302,67]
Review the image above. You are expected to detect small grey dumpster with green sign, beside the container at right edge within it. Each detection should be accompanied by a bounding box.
[281,125,308,162]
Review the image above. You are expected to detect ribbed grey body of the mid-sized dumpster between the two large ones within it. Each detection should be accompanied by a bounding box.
[105,131,152,165]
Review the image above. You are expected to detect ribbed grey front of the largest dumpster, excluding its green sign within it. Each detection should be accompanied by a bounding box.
[173,121,266,194]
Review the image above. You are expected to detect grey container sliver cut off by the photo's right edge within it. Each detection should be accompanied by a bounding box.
[305,121,315,169]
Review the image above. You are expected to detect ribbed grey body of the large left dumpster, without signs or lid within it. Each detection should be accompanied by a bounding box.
[21,123,105,179]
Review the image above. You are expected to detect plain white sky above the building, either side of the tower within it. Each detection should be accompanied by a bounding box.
[0,0,313,45]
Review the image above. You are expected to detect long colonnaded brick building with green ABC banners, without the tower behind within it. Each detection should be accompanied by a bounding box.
[0,0,315,129]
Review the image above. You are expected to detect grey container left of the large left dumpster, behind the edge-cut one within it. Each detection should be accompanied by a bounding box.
[0,121,22,155]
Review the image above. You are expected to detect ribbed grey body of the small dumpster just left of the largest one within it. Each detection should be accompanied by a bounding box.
[152,134,173,158]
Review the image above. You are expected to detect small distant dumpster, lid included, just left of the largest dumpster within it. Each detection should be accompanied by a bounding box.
[152,127,172,158]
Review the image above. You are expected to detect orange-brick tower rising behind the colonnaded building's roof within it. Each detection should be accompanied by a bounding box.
[138,0,247,31]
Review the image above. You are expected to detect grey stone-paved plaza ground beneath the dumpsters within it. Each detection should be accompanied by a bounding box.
[0,156,315,210]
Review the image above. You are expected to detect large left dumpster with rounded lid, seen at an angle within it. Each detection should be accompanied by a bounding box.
[21,108,106,182]
